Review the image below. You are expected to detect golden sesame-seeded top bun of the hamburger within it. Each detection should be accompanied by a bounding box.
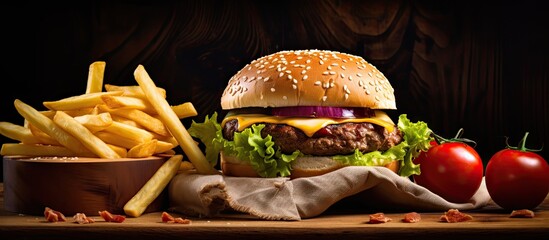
[221,50,396,110]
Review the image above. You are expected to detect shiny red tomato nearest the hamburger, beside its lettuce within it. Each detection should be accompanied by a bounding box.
[413,141,484,203]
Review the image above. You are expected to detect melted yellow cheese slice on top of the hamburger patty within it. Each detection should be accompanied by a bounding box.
[221,110,395,137]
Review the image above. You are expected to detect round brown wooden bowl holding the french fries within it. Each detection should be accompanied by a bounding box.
[3,157,168,216]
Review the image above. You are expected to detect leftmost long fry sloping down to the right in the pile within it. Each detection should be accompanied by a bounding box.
[14,99,90,155]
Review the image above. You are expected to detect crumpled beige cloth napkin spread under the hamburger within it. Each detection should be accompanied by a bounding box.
[168,167,491,220]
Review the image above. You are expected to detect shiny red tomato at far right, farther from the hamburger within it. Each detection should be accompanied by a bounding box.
[486,136,549,210]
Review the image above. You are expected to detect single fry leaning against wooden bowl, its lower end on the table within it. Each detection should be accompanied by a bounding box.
[124,155,183,217]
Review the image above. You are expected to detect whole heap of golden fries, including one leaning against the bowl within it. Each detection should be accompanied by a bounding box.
[0,61,219,217]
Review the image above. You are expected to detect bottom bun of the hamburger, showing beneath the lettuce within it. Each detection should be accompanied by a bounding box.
[220,152,400,178]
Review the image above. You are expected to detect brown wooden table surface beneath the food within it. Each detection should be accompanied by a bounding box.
[0,183,549,240]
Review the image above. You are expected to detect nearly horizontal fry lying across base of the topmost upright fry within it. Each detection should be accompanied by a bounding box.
[43,91,122,111]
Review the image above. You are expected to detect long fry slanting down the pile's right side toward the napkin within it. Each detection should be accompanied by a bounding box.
[134,65,219,174]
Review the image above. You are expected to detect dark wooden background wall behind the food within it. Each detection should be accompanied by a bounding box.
[0,0,549,180]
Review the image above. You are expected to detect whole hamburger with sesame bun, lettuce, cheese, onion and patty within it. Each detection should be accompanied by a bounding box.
[189,50,432,178]
